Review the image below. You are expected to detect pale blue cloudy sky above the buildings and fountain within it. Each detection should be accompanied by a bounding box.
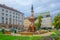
[0,0,60,17]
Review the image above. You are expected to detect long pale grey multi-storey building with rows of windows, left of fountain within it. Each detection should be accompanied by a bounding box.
[0,4,24,29]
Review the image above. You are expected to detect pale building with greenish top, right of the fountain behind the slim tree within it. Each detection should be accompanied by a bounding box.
[35,12,52,28]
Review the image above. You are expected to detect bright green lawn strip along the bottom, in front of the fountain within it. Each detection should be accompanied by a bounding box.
[0,35,42,40]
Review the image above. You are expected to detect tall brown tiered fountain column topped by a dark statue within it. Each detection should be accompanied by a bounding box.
[28,5,36,32]
